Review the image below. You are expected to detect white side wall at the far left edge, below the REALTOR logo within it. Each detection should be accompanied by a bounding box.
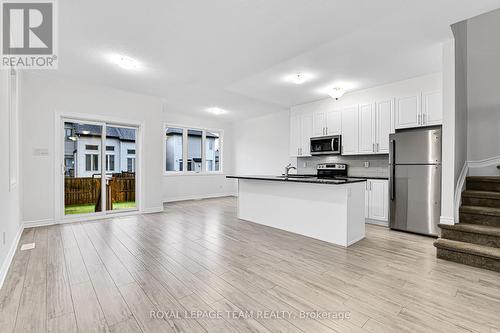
[0,70,21,286]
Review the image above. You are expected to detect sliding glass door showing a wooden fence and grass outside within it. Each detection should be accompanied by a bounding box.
[63,120,138,216]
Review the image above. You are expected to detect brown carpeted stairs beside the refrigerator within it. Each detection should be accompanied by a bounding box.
[434,177,500,272]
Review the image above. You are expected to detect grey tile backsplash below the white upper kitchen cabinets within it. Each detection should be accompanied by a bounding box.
[297,155,389,177]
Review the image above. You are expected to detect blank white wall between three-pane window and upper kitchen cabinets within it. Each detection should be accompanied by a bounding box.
[233,110,296,175]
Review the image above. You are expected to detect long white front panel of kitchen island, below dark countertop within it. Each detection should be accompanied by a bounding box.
[238,179,352,246]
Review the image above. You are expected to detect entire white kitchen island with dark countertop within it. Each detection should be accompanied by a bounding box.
[227,176,366,247]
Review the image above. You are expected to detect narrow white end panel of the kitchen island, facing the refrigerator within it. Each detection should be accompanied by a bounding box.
[346,183,366,246]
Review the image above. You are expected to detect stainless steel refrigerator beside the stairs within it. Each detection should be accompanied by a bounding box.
[389,126,442,236]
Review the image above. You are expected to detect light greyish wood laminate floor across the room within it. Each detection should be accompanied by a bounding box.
[0,198,500,333]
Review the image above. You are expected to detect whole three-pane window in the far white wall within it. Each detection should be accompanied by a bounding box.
[165,126,222,173]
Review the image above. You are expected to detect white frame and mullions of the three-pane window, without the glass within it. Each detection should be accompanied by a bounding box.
[162,123,224,176]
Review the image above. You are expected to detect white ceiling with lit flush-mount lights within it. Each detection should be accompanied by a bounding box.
[39,0,500,120]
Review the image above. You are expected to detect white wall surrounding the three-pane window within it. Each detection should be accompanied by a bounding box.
[161,110,236,202]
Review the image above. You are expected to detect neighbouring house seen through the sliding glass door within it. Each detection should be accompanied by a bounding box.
[64,122,136,178]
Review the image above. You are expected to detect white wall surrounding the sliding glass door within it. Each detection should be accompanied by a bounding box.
[21,74,163,223]
